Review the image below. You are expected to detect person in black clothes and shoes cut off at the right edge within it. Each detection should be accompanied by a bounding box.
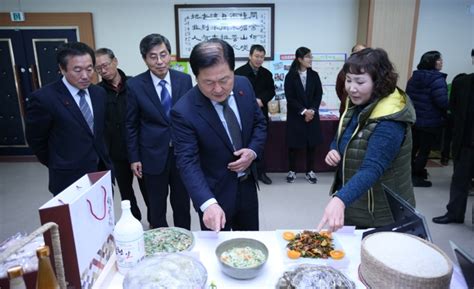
[433,49,474,224]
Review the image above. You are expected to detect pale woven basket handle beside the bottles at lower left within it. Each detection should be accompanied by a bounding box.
[0,222,66,289]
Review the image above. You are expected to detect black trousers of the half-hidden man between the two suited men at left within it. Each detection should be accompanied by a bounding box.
[112,160,150,222]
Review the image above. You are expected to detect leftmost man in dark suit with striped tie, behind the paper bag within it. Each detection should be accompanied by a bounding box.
[26,42,112,195]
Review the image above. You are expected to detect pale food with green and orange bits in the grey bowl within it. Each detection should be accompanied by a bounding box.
[221,246,265,268]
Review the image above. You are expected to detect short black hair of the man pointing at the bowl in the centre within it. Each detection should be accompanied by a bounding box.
[189,38,235,77]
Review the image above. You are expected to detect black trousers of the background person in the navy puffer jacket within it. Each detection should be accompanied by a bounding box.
[411,127,442,177]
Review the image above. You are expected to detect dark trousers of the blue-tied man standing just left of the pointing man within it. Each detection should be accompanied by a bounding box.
[143,149,191,230]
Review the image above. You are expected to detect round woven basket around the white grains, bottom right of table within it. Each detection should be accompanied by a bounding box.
[359,232,453,289]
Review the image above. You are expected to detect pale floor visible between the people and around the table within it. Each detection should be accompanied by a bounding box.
[0,162,474,264]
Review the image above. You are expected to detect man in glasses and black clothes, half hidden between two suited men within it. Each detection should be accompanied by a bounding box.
[95,48,150,222]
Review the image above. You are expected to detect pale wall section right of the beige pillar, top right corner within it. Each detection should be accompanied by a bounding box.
[413,0,474,83]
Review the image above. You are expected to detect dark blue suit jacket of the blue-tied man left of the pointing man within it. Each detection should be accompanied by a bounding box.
[126,69,192,175]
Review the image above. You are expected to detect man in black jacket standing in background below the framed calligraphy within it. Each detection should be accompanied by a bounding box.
[235,44,275,185]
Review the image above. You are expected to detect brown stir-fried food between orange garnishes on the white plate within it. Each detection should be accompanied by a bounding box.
[286,231,334,259]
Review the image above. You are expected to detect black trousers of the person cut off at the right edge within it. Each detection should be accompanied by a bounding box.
[446,147,474,220]
